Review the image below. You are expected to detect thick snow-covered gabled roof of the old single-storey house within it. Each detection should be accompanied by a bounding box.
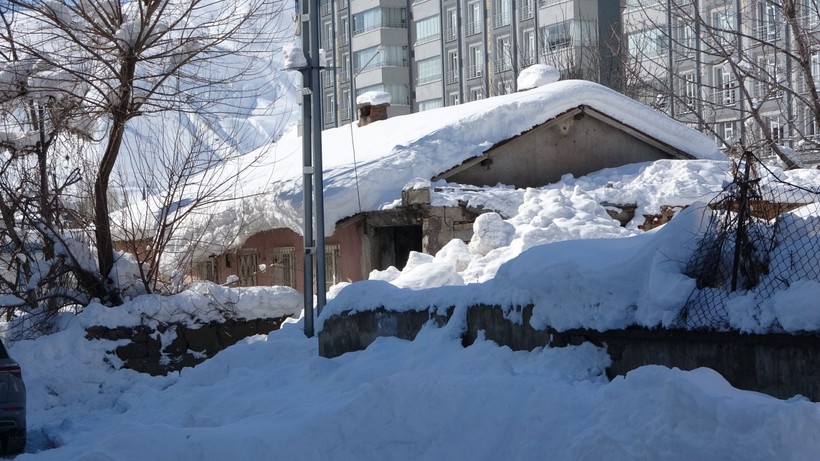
[120,80,725,262]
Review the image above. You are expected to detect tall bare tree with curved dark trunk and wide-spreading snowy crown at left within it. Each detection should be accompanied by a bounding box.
[0,0,284,304]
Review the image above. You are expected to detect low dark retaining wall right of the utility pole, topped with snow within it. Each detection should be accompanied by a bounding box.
[319,305,820,401]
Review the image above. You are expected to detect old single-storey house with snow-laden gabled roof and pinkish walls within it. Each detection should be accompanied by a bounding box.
[117,77,723,289]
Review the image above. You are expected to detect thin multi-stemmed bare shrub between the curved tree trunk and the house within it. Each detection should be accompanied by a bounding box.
[113,109,280,293]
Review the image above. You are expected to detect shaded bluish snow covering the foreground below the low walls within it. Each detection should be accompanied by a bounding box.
[13,314,820,461]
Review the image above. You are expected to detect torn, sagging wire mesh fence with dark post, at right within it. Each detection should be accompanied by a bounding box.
[675,153,820,331]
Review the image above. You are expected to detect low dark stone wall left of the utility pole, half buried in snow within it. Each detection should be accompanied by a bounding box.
[86,317,287,376]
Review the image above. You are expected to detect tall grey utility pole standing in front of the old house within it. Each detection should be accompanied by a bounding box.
[296,0,327,337]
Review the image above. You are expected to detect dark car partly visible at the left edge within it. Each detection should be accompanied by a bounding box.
[0,341,26,454]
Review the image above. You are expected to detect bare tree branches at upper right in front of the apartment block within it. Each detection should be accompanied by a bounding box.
[624,0,820,168]
